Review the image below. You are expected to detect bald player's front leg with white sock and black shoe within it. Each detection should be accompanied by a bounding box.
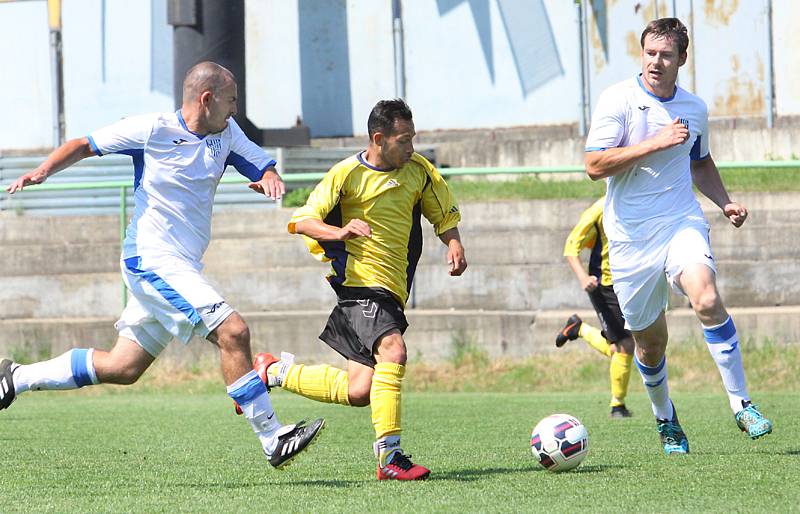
[207,312,324,468]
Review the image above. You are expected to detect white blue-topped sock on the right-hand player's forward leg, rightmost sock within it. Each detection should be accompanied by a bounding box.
[703,316,750,414]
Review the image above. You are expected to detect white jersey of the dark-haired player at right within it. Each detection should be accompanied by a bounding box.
[586,76,709,241]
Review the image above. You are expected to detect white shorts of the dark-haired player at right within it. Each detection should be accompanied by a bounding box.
[608,221,717,330]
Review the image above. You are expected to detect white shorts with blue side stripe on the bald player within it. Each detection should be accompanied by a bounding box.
[114,257,233,357]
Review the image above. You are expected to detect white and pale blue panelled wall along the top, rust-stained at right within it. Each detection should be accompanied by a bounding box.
[0,0,800,150]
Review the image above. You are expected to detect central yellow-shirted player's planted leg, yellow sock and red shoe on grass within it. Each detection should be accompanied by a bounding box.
[370,329,430,480]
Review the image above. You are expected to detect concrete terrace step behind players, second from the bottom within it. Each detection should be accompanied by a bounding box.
[0,259,800,319]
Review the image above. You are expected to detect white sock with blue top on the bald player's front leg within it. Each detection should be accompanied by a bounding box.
[228,370,285,456]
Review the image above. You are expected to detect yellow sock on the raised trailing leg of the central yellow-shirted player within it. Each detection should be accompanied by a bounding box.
[280,364,350,405]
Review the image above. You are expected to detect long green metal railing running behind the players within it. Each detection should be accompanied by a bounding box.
[12,160,800,306]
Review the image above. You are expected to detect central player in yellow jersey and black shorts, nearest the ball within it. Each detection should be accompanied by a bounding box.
[247,100,467,480]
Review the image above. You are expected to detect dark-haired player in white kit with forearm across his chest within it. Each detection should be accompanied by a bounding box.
[585,18,772,454]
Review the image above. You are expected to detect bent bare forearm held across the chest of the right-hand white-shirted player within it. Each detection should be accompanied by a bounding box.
[583,118,689,180]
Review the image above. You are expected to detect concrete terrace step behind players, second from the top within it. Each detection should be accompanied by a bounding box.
[9,220,800,276]
